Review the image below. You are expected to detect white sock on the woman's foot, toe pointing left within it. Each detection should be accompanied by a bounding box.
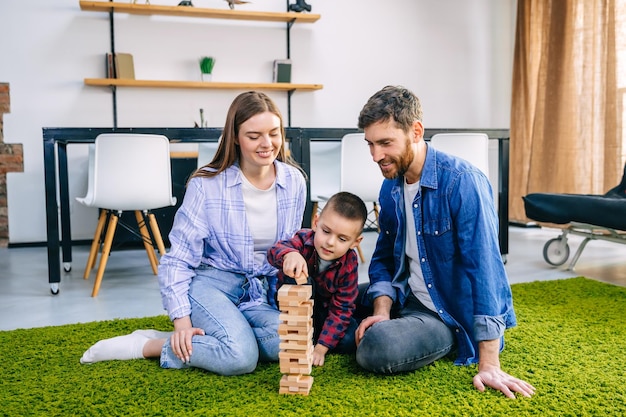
[80,333,150,363]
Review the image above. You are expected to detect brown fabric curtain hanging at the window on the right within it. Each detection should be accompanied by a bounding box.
[509,0,626,222]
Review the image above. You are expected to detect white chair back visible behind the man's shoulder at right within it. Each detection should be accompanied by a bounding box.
[430,133,489,177]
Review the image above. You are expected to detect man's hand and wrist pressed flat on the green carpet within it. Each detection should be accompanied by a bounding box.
[473,339,535,398]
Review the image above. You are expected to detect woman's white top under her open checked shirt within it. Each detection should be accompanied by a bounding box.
[241,175,278,266]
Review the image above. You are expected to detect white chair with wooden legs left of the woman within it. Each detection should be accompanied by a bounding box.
[76,134,176,297]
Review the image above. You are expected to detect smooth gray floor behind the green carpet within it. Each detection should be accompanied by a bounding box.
[0,227,626,330]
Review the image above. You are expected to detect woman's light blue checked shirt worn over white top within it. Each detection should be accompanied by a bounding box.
[159,161,306,320]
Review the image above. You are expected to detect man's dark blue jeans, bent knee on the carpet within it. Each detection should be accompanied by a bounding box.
[356,294,455,374]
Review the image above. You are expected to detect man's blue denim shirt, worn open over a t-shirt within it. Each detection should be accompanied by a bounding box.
[366,146,516,365]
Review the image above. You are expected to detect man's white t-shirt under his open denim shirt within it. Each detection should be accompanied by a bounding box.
[404,181,436,311]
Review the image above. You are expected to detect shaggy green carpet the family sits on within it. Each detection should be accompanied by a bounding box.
[0,278,626,417]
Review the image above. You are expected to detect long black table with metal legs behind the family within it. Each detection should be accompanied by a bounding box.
[42,127,509,293]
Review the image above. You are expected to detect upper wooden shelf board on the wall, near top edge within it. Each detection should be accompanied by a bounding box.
[80,1,320,23]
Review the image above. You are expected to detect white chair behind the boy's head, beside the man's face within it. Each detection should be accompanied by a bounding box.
[313,133,384,262]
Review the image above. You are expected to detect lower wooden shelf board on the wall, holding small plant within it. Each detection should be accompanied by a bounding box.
[85,78,323,91]
